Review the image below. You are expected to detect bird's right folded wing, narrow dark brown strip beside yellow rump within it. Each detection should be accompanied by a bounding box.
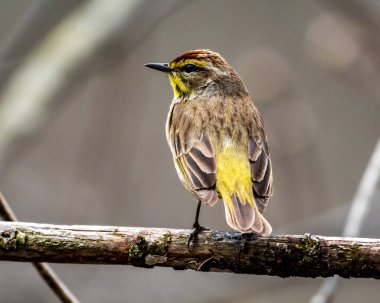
[248,131,273,212]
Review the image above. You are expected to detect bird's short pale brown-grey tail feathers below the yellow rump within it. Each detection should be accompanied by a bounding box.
[223,194,272,236]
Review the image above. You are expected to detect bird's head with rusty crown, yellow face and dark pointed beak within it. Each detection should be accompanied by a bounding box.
[145,49,247,100]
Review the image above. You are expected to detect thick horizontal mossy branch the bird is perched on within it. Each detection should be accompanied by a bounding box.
[0,222,380,279]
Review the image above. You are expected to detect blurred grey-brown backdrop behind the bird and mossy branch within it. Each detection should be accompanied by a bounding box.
[0,0,380,303]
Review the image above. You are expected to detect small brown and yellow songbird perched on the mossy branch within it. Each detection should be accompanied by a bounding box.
[145,49,272,241]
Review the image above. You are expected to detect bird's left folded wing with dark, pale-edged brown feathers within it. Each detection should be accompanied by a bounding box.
[169,111,218,204]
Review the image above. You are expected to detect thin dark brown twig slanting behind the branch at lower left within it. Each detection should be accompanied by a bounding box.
[0,192,79,303]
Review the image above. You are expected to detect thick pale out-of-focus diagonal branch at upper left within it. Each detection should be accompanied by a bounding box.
[0,0,138,167]
